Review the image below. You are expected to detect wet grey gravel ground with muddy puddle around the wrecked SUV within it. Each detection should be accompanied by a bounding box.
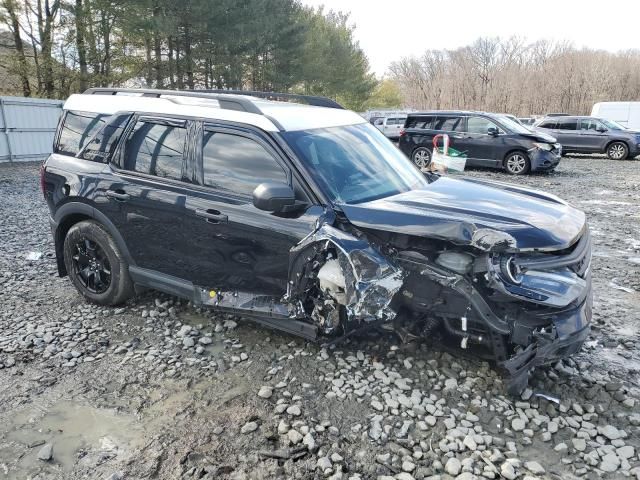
[0,157,640,480]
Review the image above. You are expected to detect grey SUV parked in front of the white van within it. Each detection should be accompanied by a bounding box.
[535,116,640,160]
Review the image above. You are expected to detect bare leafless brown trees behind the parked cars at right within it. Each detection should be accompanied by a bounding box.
[390,37,640,115]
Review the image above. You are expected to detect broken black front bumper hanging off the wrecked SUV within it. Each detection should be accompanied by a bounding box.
[499,288,593,395]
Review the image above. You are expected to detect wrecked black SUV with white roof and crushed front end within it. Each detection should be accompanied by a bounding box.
[40,89,591,392]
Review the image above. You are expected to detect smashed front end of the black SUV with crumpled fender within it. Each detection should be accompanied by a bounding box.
[286,171,591,394]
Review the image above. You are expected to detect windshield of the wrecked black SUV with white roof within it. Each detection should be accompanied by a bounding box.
[282,123,429,204]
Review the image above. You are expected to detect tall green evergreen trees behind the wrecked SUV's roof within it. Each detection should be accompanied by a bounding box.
[0,0,378,109]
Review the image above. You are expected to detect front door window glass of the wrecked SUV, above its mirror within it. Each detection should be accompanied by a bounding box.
[202,131,288,196]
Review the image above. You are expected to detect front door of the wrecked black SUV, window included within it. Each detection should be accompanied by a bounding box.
[185,127,323,296]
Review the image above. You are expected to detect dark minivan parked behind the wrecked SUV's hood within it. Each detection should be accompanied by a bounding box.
[398,111,562,175]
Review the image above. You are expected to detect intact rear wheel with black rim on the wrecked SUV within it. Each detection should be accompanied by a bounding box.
[63,220,133,306]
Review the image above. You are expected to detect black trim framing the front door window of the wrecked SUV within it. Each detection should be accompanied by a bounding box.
[194,122,294,202]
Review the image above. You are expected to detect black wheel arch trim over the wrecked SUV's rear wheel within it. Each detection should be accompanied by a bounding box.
[49,202,135,277]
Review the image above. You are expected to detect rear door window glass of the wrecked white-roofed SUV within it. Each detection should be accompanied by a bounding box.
[124,122,187,180]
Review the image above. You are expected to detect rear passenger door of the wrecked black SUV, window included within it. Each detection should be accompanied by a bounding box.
[110,116,192,279]
